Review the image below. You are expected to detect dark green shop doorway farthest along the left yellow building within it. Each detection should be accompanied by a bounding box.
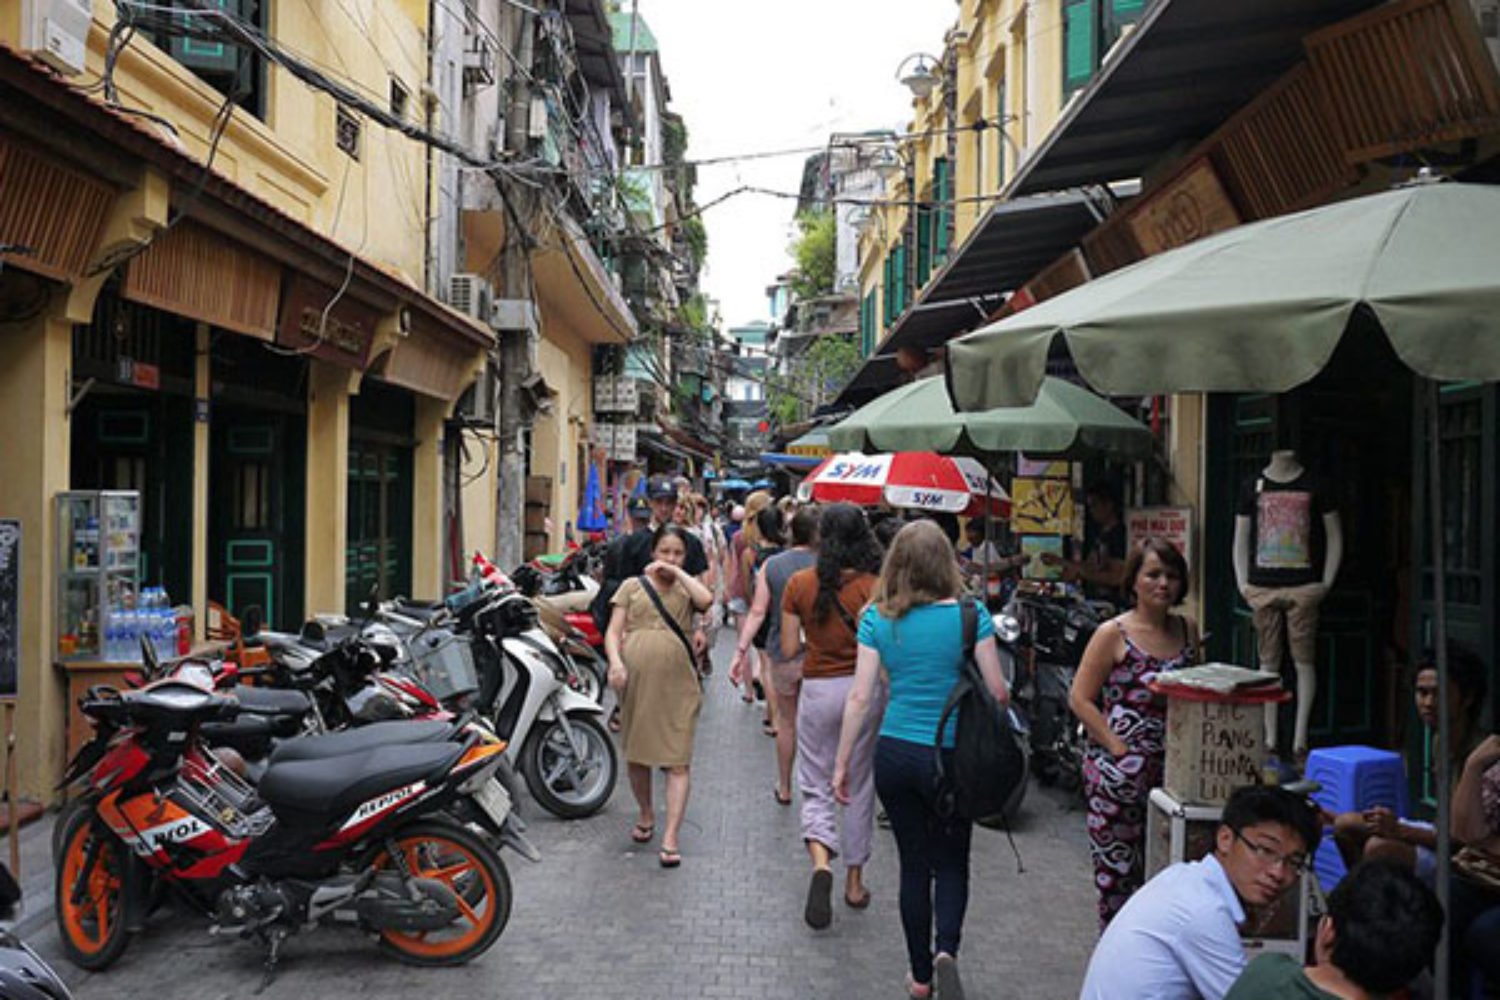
[345,378,414,615]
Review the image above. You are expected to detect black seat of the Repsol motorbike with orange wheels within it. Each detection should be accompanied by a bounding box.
[260,742,464,822]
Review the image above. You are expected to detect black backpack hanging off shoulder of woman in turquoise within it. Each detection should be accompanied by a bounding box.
[935,600,1028,826]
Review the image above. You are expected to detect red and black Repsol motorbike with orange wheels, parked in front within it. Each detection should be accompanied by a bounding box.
[54,678,512,978]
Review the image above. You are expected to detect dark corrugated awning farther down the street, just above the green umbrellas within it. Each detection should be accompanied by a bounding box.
[831,192,1107,409]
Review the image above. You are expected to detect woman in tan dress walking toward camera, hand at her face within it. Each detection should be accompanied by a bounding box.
[605,522,714,868]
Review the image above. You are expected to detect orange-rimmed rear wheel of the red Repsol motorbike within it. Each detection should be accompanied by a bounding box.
[374,822,512,967]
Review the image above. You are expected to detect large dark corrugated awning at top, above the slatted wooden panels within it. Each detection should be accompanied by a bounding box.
[1005,0,1382,198]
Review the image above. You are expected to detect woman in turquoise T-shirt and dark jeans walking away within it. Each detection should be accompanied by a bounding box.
[824,520,1010,1000]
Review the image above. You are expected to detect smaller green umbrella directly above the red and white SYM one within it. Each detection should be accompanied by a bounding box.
[827,376,1151,459]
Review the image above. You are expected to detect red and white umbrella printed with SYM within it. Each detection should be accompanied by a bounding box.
[797,451,1011,517]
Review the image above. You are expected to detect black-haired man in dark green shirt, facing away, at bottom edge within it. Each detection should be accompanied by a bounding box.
[1224,861,1443,1000]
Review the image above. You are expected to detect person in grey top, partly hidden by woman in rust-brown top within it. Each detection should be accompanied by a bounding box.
[729,507,818,805]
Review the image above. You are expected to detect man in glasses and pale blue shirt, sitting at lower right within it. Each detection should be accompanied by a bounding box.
[1080,786,1319,1000]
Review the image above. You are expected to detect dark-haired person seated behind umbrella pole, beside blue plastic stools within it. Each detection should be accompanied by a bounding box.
[1334,643,1488,886]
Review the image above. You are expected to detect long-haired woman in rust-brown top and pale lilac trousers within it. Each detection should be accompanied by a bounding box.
[780,504,881,930]
